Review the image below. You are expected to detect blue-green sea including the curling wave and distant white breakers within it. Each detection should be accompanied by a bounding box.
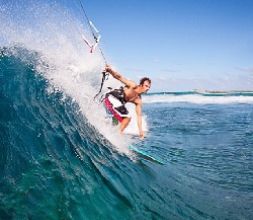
[0,47,253,220]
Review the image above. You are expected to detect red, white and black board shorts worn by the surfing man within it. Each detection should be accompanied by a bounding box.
[104,94,130,122]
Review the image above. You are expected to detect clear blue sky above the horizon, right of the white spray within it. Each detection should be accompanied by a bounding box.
[75,0,253,91]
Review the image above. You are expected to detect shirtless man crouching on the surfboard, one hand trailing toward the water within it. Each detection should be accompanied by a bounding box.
[104,65,151,139]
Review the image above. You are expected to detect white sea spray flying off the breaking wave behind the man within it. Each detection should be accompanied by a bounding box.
[0,1,136,153]
